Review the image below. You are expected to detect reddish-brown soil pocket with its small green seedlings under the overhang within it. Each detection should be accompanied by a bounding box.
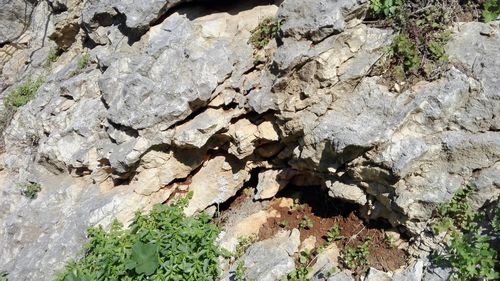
[258,186,407,280]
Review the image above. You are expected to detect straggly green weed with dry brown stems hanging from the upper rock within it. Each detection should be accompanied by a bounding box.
[370,0,453,81]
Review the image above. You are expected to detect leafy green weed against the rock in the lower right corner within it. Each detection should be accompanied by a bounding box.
[433,186,500,280]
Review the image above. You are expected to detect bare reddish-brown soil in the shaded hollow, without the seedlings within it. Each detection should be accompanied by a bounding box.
[258,185,407,275]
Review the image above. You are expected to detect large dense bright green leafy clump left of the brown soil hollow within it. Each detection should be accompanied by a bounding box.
[56,197,219,281]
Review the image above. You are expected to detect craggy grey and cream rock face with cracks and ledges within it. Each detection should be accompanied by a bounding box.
[0,0,500,280]
